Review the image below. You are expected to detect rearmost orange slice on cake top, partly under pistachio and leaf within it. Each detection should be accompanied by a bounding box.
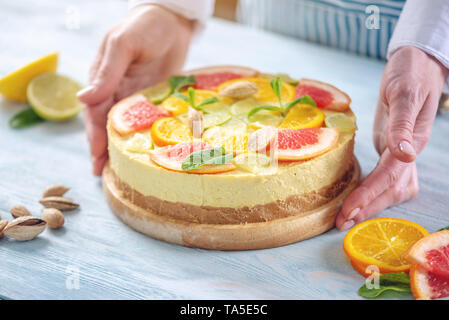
[217,78,295,105]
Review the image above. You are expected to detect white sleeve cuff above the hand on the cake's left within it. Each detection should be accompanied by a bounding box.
[129,0,215,34]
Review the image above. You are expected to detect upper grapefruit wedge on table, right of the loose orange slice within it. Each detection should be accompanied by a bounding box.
[406,230,449,279]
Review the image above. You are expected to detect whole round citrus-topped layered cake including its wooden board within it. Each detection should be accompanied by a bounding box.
[103,66,360,250]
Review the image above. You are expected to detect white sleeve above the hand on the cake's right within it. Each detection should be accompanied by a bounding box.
[387,0,449,92]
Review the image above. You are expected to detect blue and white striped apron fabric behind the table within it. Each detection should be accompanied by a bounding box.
[237,0,405,59]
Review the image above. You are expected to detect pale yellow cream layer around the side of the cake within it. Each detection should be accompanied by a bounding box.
[107,116,354,208]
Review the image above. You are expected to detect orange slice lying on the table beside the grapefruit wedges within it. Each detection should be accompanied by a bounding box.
[343,218,429,273]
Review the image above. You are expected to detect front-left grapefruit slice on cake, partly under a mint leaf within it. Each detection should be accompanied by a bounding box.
[149,141,235,174]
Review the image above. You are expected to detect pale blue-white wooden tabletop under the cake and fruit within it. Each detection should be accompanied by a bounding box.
[0,0,449,299]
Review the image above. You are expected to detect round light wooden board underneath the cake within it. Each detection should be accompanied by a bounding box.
[103,157,360,250]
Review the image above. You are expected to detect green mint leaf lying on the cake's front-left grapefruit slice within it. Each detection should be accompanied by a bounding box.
[181,147,233,171]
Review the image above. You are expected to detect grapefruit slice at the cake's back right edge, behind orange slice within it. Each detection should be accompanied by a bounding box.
[295,79,351,111]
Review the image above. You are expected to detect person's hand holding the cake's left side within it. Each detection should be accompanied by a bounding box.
[78,4,193,176]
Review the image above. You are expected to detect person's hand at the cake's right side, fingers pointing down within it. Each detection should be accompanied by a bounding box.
[336,47,448,230]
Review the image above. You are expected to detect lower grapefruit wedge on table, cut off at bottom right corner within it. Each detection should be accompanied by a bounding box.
[410,264,449,299]
